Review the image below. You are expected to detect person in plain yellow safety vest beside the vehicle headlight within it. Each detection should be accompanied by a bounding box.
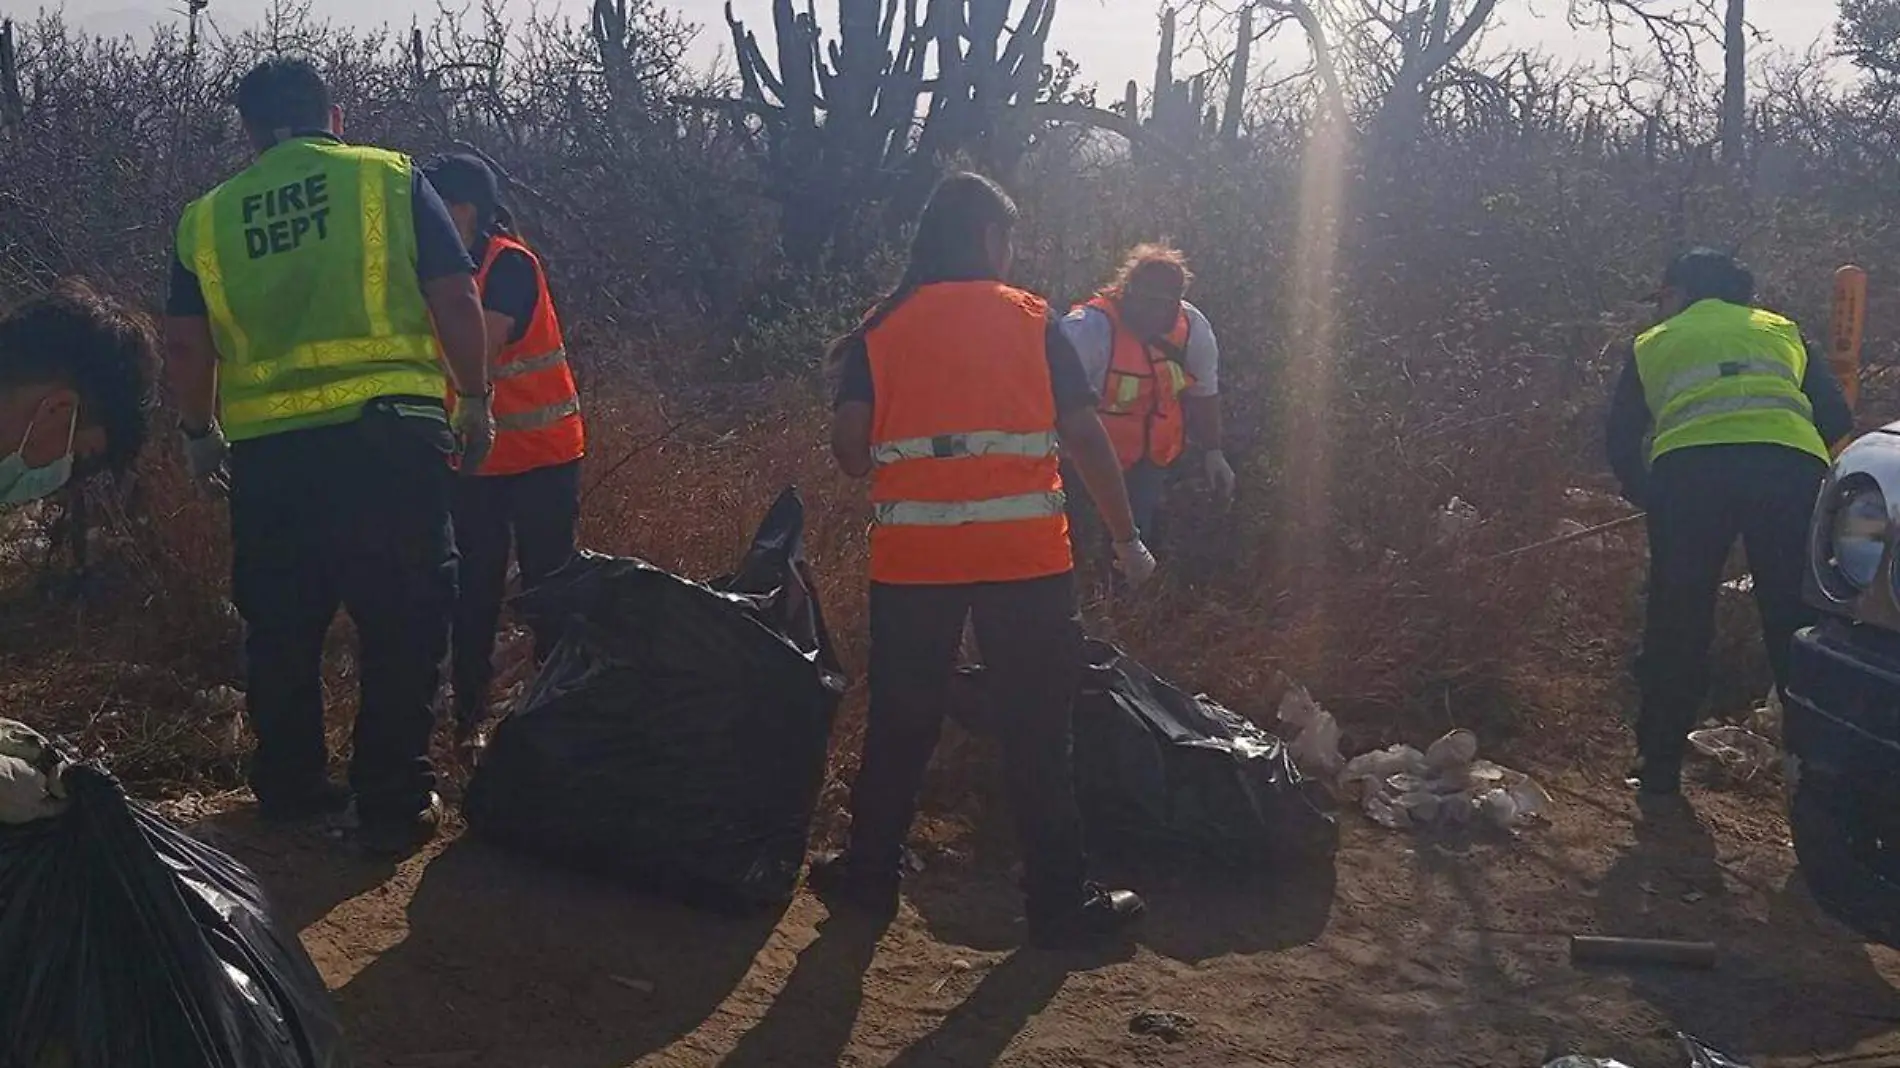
[1606,249,1853,796]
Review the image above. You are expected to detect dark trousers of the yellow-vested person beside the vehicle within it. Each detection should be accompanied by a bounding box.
[1636,445,1828,764]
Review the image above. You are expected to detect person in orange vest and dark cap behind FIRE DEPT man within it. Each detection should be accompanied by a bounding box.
[426,156,587,739]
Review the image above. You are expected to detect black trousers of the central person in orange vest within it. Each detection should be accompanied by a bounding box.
[851,574,1087,916]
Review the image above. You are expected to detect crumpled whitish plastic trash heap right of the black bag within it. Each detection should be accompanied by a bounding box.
[1340,728,1552,830]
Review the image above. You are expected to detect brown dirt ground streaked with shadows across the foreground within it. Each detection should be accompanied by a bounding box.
[171,760,1900,1068]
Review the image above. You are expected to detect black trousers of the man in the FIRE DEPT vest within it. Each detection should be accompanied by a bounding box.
[232,401,456,823]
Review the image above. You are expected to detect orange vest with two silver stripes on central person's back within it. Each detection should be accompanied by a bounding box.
[865,281,1074,585]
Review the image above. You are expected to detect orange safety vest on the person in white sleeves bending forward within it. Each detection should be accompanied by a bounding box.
[1089,296,1193,471]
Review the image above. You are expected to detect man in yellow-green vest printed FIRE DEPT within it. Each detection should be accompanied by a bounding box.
[165,57,494,853]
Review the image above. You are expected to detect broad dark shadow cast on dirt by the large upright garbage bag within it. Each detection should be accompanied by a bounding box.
[336,838,777,1068]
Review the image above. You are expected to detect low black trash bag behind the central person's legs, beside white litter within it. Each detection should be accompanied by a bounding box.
[952,639,1340,868]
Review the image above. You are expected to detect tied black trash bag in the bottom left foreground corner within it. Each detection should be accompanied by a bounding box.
[0,764,350,1068]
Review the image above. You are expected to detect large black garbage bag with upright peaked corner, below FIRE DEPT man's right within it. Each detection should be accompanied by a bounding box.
[467,488,846,908]
